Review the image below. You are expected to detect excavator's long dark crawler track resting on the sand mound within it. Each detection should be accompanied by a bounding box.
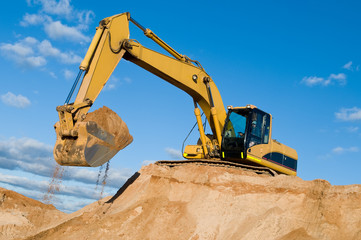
[155,159,278,176]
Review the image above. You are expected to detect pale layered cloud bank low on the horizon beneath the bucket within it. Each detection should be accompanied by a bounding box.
[0,138,132,211]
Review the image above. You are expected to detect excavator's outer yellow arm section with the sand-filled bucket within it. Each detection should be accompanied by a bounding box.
[54,14,133,167]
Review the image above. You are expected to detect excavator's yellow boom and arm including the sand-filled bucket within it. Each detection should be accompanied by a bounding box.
[54,13,227,167]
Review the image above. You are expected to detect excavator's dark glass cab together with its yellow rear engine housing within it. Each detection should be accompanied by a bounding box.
[221,105,298,175]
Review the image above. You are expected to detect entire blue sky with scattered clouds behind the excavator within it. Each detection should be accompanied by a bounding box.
[0,0,361,211]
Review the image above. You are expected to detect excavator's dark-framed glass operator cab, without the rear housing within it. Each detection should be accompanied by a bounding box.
[221,105,271,161]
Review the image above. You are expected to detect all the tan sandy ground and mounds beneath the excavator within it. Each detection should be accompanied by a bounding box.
[0,164,361,240]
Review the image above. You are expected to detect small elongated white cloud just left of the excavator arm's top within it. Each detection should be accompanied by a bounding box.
[44,21,90,42]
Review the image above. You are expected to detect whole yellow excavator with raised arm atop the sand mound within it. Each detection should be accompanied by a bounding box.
[54,13,298,175]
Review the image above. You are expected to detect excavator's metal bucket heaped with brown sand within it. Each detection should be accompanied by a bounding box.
[54,107,133,167]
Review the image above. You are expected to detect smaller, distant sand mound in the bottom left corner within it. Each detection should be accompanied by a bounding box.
[0,188,67,240]
